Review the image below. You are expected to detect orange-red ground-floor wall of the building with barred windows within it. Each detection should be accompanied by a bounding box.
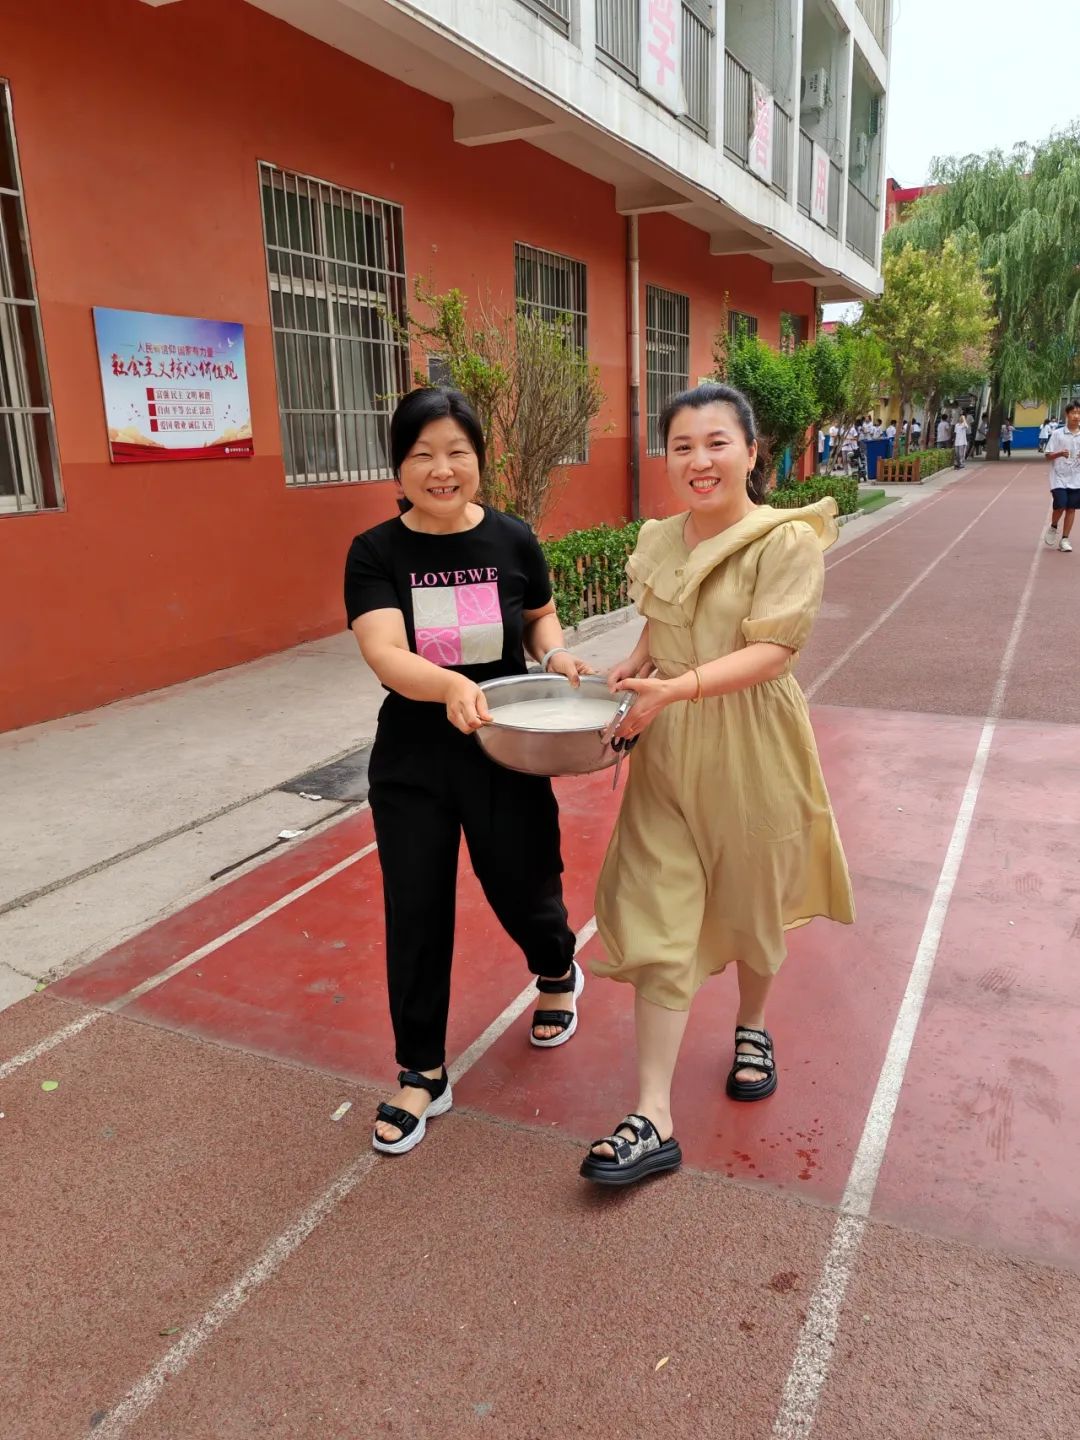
[0,0,812,729]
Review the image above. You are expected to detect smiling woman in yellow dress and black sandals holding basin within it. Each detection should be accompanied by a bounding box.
[582,384,854,1185]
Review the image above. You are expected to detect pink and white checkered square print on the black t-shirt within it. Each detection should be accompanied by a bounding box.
[409,567,504,667]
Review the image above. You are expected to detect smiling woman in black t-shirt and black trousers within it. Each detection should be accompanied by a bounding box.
[346,389,590,1155]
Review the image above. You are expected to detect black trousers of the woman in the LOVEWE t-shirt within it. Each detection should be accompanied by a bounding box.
[369,710,575,1070]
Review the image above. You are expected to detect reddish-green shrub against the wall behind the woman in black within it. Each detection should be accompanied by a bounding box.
[400,278,605,528]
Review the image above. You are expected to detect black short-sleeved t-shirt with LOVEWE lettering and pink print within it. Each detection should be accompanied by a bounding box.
[346,505,552,717]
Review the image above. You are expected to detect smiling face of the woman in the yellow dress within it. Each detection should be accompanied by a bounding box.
[667,400,757,516]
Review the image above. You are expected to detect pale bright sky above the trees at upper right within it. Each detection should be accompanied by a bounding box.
[886,0,1080,186]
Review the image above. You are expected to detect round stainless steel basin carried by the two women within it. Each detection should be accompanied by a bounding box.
[477,674,632,775]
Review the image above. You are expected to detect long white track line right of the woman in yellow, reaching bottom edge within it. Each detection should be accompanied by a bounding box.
[772,512,1043,1440]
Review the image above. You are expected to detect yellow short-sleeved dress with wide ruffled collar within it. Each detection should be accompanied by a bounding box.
[592,500,855,1009]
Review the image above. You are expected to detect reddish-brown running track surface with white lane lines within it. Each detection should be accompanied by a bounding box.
[0,464,1080,1440]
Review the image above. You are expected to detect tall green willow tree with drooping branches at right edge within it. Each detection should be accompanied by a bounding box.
[886,125,1080,429]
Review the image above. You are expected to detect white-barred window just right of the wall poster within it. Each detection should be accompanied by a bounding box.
[259,161,409,490]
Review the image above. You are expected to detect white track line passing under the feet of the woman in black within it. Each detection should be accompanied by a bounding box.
[86,916,596,1440]
